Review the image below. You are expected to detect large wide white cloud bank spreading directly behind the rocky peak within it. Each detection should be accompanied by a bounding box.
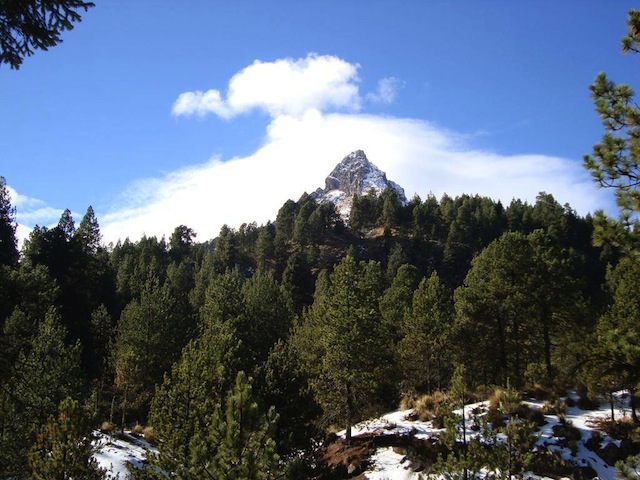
[101,110,610,241]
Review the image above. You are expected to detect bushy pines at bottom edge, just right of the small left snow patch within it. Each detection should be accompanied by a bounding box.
[148,372,279,480]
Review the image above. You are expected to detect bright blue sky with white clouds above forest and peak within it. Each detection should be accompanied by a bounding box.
[0,0,640,241]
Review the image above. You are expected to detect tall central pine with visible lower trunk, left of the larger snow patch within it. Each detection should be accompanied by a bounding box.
[294,256,391,439]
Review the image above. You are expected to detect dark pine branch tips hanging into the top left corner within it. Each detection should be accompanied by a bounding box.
[0,0,94,70]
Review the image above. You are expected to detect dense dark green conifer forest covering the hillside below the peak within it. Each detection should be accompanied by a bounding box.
[0,168,640,478]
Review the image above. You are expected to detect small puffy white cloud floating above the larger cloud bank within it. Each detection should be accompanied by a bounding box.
[173,54,361,118]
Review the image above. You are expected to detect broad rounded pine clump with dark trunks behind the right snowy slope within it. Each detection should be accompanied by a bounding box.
[456,232,581,386]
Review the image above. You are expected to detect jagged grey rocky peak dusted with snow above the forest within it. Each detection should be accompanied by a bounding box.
[310,150,407,220]
